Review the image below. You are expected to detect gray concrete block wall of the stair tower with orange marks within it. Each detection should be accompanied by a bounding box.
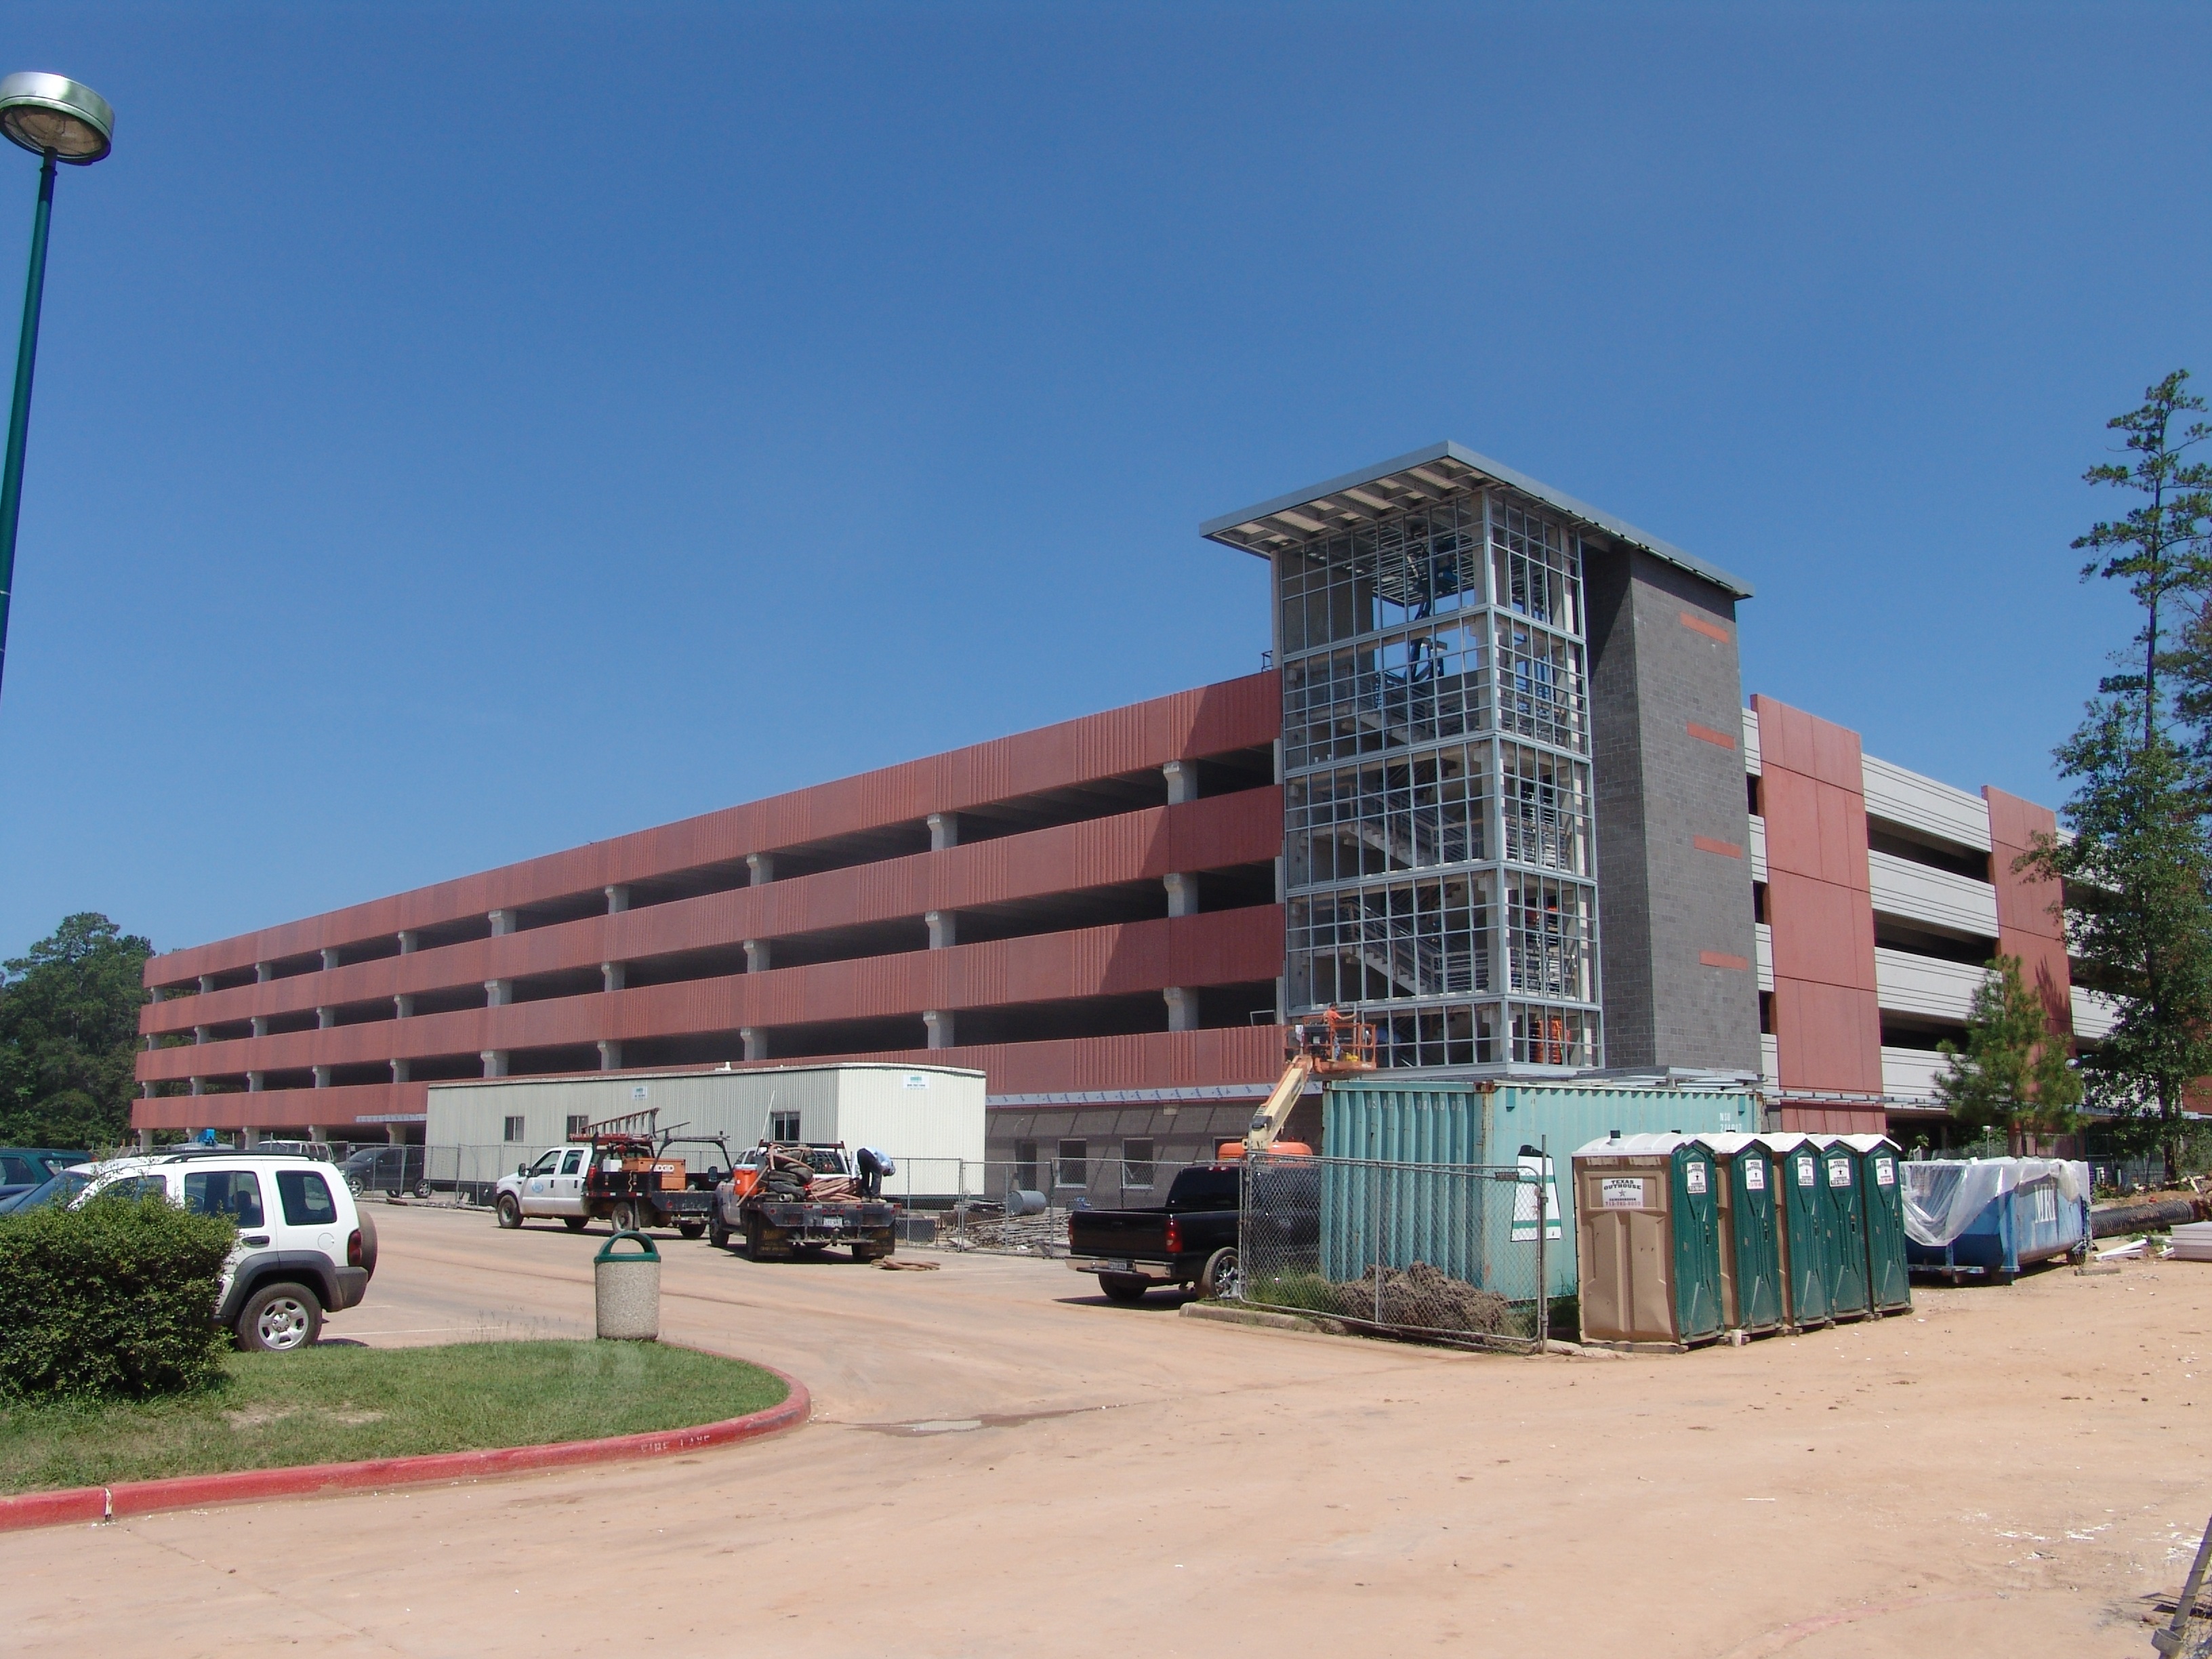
[1584,548,1759,1071]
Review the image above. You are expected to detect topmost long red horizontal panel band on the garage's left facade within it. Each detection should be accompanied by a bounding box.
[146,670,1283,984]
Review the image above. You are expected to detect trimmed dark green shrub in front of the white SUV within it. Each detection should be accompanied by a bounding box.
[0,1197,237,1400]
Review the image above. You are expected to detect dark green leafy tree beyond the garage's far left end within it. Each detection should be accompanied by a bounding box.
[0,912,152,1148]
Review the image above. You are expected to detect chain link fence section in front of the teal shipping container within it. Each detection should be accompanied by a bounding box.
[1237,1153,1561,1351]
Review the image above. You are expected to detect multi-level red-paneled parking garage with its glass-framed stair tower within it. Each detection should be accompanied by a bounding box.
[135,445,2097,1164]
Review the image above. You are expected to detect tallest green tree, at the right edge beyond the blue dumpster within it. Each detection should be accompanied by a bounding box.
[2020,369,2212,1174]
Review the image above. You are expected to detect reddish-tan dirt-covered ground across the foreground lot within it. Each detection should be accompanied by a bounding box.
[0,1208,2212,1659]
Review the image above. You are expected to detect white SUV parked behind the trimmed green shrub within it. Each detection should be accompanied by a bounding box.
[70,1150,376,1354]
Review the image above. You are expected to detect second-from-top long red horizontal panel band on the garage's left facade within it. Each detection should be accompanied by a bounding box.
[140,787,1283,1036]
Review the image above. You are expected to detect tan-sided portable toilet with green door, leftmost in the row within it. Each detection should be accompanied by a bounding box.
[1573,1132,1721,1347]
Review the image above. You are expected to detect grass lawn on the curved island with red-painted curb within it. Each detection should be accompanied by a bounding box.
[0,1343,785,1493]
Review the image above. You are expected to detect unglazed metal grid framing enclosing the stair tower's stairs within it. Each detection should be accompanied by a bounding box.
[1274,491,1603,1066]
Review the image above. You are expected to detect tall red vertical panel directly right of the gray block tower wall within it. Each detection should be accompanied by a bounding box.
[1752,697,1883,1097]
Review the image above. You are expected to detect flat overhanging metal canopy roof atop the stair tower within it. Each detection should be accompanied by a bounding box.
[1199,441,1752,600]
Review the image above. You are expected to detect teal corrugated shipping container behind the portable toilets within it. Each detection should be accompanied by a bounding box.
[1321,1073,1759,1296]
